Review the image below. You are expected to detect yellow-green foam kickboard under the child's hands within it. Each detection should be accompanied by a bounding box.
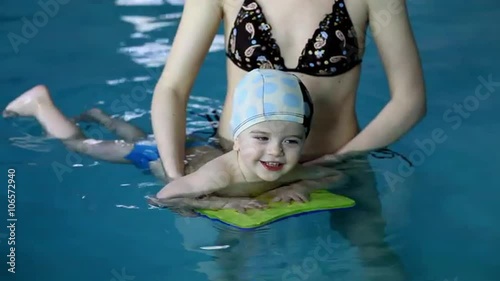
[197,190,356,229]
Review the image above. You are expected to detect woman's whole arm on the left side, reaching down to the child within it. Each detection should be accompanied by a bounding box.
[151,0,222,179]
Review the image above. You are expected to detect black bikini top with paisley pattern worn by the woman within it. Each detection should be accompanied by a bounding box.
[226,0,361,76]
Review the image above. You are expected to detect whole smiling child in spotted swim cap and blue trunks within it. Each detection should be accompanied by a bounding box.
[3,69,341,211]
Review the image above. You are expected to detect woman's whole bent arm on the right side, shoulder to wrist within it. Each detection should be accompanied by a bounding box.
[337,0,426,154]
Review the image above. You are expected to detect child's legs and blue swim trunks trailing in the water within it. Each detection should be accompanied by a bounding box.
[3,85,223,182]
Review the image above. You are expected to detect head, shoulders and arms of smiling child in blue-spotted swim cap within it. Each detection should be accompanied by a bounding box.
[146,69,341,211]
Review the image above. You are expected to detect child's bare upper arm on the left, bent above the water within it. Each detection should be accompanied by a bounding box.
[156,157,232,199]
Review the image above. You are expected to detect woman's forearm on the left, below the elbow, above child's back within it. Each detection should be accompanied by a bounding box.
[151,85,187,179]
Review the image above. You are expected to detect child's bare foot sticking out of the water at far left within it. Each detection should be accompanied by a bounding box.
[2,85,50,118]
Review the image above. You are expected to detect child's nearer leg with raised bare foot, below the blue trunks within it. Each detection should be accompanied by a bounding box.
[3,86,133,163]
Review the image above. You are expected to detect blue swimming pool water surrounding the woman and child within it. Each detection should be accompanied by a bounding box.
[0,0,500,281]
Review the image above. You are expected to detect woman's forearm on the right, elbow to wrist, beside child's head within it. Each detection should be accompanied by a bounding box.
[336,95,426,154]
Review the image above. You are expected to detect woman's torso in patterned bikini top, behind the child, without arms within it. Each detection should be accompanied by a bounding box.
[218,0,367,161]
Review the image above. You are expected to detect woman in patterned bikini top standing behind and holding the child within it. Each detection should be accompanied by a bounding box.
[152,0,426,280]
